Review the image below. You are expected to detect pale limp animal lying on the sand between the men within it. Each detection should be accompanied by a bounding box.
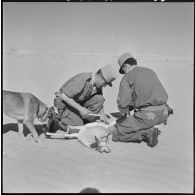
[46,116,126,153]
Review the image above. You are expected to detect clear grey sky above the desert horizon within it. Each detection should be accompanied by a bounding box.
[3,2,194,56]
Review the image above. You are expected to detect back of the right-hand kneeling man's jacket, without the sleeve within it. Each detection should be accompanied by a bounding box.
[122,66,168,108]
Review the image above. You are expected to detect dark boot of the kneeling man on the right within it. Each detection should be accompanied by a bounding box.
[141,128,160,148]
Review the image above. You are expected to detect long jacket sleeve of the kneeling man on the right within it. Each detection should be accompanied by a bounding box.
[117,78,134,113]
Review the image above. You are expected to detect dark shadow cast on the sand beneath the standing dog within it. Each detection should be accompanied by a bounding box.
[3,123,44,136]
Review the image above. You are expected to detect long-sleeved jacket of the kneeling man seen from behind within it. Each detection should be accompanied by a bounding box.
[117,66,168,113]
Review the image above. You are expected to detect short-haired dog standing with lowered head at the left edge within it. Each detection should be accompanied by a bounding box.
[3,90,55,143]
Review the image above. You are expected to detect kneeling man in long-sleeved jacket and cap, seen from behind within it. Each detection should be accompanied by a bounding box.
[112,53,173,147]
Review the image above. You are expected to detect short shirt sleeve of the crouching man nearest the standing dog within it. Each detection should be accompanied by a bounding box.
[60,73,86,98]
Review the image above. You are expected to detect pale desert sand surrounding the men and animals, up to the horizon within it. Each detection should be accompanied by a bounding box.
[2,53,194,193]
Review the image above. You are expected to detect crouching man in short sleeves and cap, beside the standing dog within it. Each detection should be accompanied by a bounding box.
[49,64,116,133]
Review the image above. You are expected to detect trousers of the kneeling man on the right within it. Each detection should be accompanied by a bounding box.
[112,104,169,143]
